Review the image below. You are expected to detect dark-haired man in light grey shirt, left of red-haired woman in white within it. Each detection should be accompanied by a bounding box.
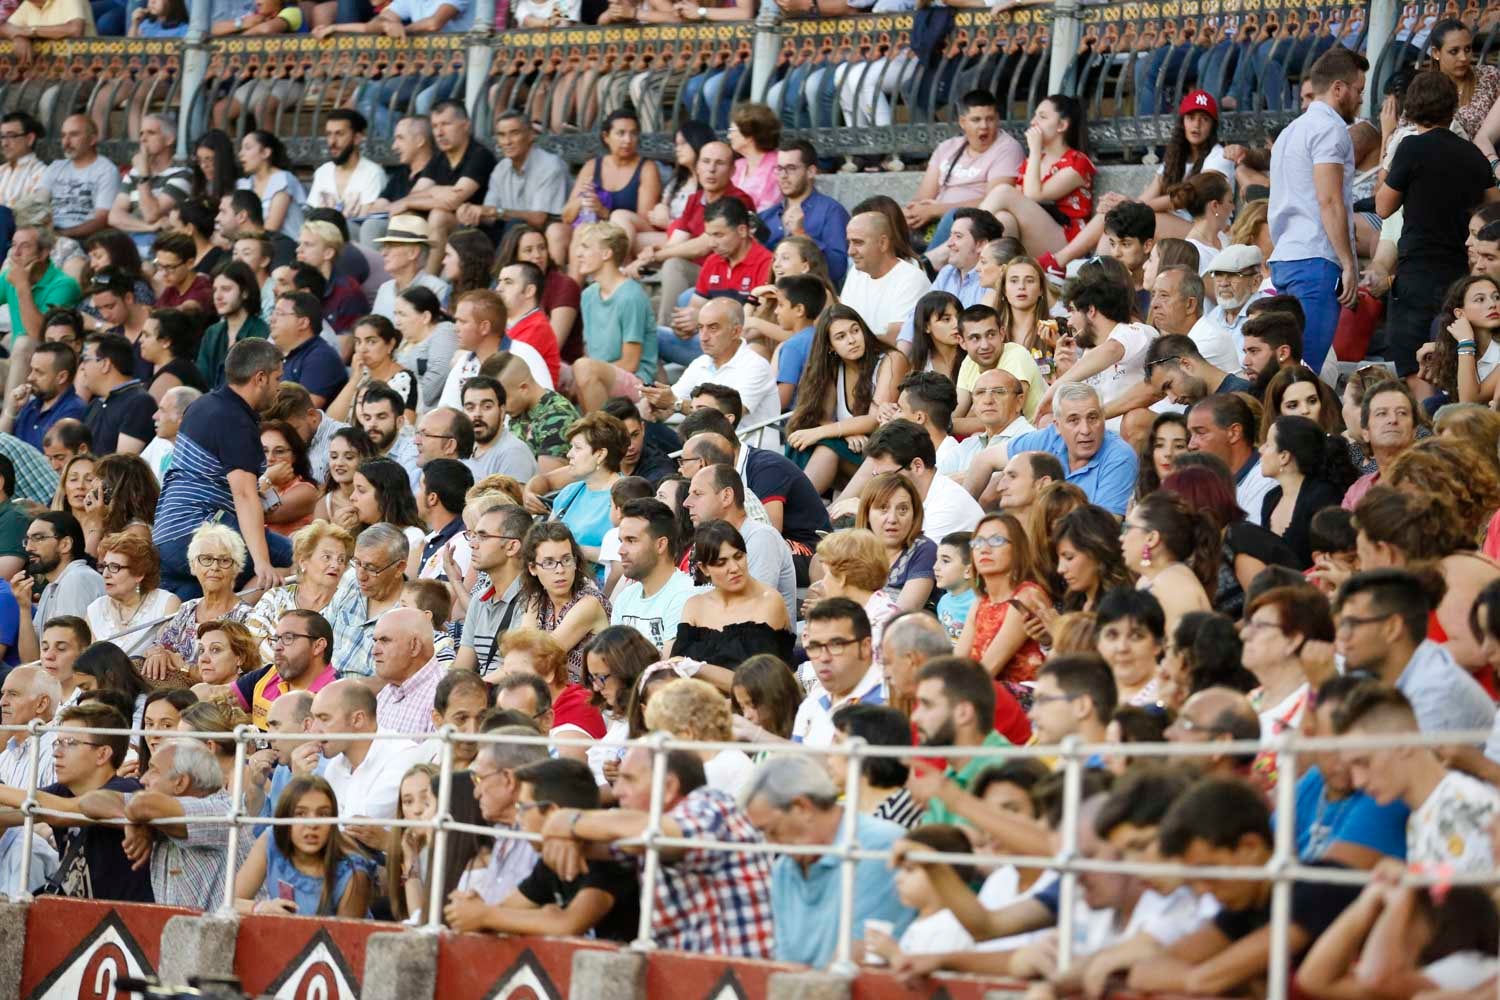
[11,510,104,663]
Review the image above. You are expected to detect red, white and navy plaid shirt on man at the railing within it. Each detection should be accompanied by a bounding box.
[639,787,776,958]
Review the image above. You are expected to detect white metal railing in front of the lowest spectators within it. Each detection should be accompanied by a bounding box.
[0,720,1500,1000]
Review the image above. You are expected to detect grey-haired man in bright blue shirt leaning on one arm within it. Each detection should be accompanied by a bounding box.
[992,382,1137,514]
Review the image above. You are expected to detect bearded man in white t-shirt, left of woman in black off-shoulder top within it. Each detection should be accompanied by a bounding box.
[609,496,698,649]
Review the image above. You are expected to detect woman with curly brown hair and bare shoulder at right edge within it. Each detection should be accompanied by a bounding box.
[1355,483,1500,673]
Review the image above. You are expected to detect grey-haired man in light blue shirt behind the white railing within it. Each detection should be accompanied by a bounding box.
[741,756,917,969]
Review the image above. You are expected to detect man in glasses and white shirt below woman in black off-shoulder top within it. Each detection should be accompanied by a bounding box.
[792,597,885,747]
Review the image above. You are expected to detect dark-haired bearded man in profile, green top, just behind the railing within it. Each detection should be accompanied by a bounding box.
[912,657,1011,823]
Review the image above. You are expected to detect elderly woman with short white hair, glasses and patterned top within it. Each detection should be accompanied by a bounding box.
[141,523,251,687]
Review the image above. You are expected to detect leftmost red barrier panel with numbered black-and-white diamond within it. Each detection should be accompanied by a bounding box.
[21,897,194,1000]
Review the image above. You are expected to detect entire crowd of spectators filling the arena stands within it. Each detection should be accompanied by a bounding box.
[0,23,1500,1000]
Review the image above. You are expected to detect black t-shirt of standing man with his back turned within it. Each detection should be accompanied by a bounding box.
[1386,129,1496,274]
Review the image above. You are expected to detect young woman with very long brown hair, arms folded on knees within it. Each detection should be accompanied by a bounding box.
[786,304,906,493]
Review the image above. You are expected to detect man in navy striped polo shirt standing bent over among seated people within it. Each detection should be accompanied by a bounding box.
[152,340,291,600]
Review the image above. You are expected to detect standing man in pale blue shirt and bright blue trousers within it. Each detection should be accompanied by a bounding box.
[1268,46,1370,372]
